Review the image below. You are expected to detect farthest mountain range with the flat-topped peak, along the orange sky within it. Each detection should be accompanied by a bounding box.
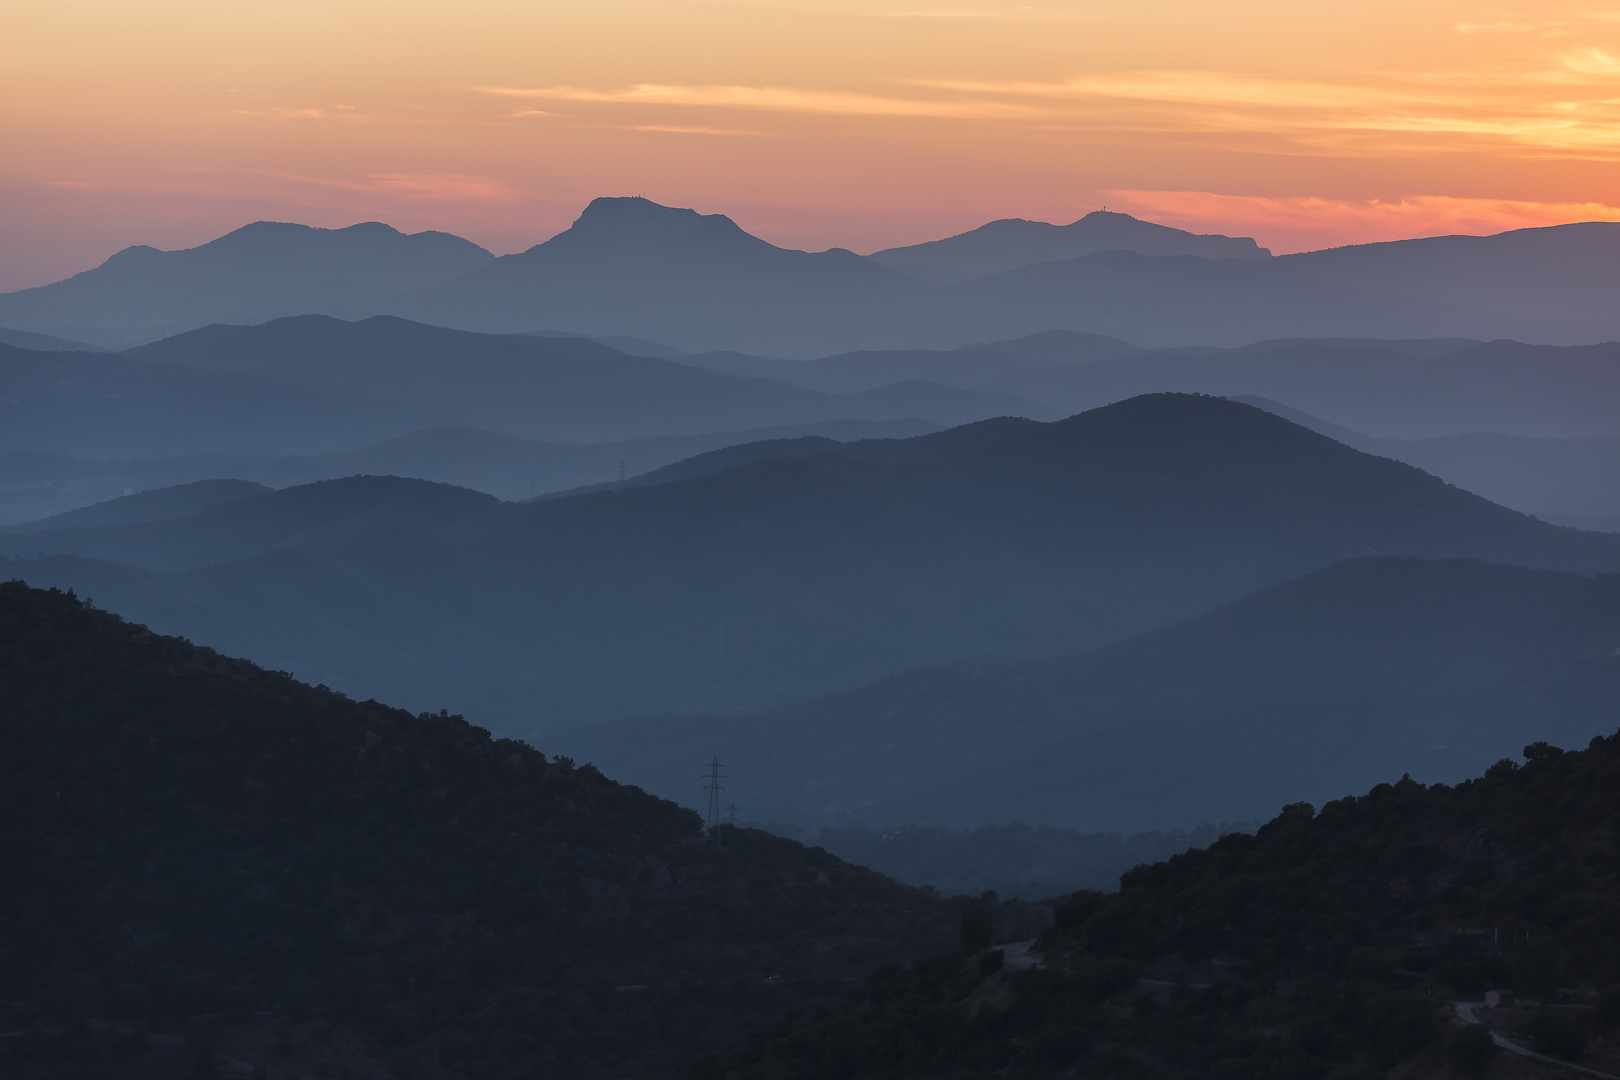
[0,198,1620,356]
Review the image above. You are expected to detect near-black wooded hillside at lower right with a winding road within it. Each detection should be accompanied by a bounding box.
[676,737,1620,1080]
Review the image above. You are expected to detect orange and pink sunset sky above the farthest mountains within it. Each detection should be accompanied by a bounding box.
[0,0,1620,290]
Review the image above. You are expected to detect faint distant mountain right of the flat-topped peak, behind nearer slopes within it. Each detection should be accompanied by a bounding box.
[870,210,1272,283]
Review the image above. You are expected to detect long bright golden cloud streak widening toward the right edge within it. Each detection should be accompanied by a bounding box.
[475,45,1620,160]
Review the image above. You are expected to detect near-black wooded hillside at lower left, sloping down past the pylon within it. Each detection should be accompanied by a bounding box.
[0,581,956,1078]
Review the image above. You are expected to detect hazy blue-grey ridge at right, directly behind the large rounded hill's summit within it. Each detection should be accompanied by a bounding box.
[696,330,1620,439]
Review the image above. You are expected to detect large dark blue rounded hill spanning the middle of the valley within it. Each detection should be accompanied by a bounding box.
[11,395,1620,730]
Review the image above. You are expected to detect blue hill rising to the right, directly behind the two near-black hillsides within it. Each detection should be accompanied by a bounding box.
[559,557,1620,831]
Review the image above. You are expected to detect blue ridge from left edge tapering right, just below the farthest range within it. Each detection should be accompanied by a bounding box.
[0,316,1036,458]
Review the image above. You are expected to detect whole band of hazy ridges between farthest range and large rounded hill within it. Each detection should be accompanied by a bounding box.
[9,316,1620,528]
